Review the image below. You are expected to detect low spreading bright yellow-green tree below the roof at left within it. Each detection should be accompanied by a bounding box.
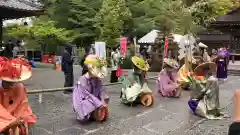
[6,19,74,51]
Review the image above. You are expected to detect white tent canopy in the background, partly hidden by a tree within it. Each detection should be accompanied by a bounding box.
[138,30,183,44]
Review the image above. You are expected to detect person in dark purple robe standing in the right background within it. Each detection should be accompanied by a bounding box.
[216,50,228,81]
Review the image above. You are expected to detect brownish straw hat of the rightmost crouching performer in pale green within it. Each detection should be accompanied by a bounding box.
[194,62,217,76]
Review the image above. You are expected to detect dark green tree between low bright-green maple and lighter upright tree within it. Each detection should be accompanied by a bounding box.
[43,0,102,45]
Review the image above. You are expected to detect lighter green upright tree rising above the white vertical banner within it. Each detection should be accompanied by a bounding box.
[95,0,131,46]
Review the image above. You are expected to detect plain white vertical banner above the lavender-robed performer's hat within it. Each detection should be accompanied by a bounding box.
[95,42,106,59]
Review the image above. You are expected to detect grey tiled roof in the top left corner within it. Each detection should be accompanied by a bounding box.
[0,0,42,11]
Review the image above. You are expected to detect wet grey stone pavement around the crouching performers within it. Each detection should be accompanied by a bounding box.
[24,68,237,135]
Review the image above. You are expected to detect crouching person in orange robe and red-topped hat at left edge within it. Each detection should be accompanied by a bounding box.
[0,57,36,135]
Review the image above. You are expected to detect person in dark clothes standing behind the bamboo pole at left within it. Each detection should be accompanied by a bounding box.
[62,44,74,94]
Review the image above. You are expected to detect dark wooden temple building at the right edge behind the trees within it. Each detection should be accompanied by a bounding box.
[198,8,240,59]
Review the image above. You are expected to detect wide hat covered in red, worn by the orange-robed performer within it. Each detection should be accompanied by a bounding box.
[0,57,32,82]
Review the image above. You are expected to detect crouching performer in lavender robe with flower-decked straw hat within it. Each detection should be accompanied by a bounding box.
[73,54,109,122]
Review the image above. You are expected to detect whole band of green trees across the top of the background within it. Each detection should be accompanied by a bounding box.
[4,0,240,48]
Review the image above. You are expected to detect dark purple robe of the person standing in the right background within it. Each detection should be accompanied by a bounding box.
[216,56,228,79]
